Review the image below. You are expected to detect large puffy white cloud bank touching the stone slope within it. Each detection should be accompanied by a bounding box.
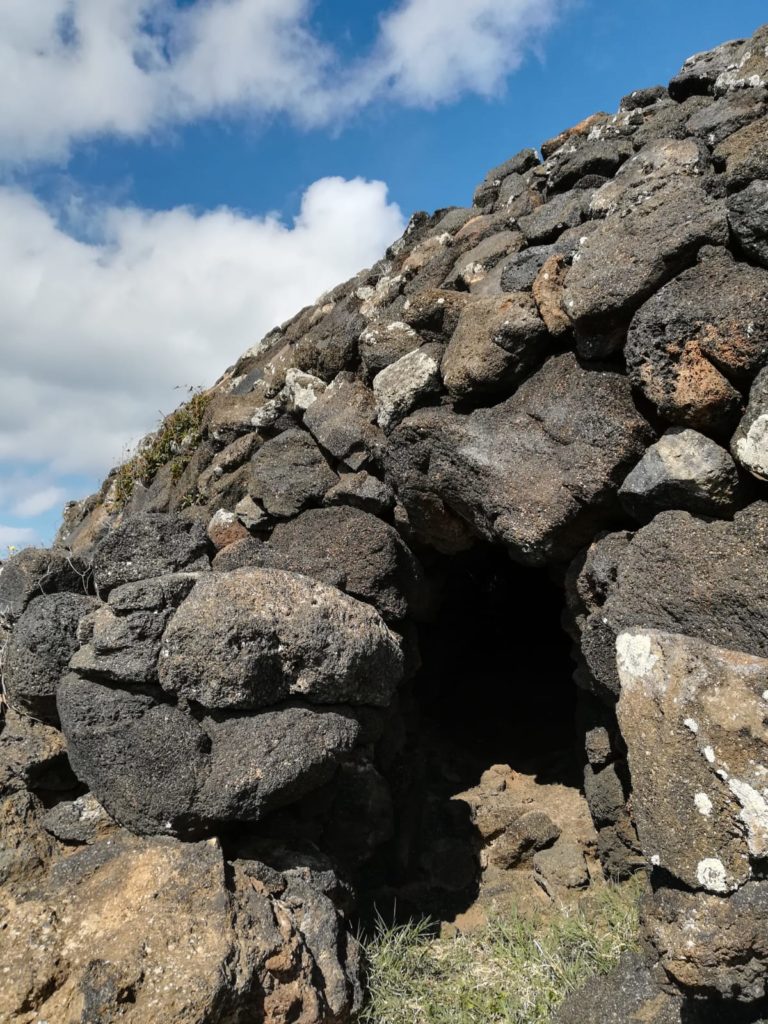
[0,178,403,479]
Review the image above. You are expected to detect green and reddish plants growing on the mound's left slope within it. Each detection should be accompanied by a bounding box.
[114,392,208,509]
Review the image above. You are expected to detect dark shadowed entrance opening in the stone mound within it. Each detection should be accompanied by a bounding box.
[364,545,582,921]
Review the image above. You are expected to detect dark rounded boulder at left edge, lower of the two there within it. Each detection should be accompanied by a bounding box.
[3,593,98,725]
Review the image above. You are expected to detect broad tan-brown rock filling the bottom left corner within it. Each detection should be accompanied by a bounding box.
[0,834,360,1024]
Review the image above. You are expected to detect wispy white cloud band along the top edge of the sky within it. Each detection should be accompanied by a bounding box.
[0,0,569,164]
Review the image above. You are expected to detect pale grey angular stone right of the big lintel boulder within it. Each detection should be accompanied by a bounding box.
[618,427,738,519]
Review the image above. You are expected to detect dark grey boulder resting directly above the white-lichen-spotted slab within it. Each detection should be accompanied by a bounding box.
[581,502,768,699]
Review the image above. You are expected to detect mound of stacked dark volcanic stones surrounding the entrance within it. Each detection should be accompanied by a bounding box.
[0,28,768,1024]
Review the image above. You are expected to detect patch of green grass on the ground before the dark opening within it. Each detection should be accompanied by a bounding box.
[361,879,643,1024]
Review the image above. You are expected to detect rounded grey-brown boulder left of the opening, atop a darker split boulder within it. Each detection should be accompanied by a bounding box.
[159,568,402,710]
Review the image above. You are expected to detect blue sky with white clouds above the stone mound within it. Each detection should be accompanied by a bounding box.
[0,0,768,558]
